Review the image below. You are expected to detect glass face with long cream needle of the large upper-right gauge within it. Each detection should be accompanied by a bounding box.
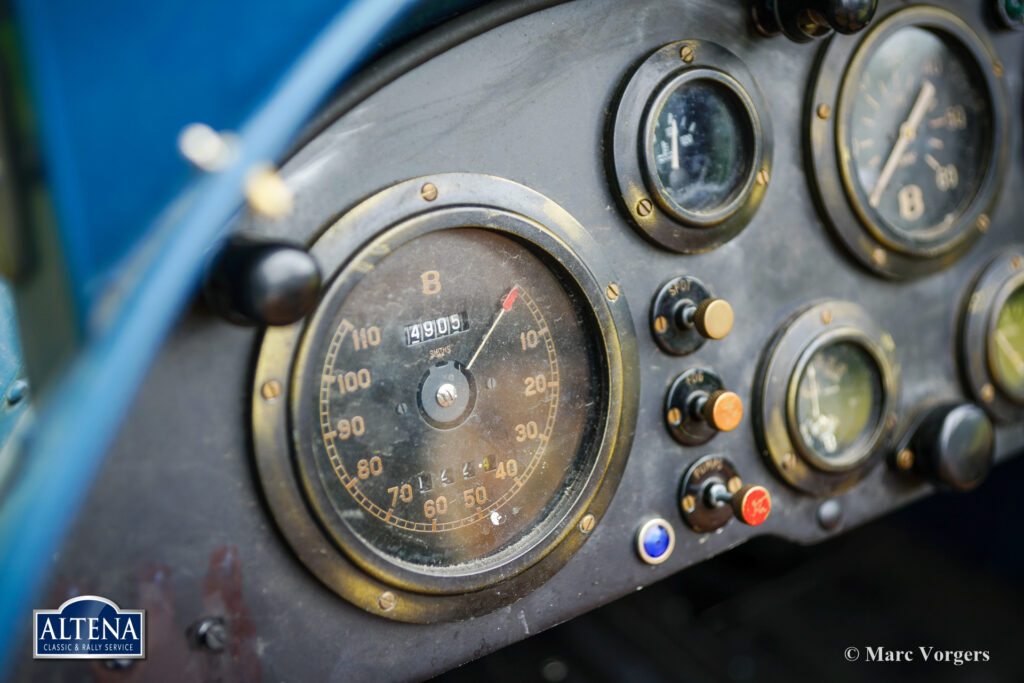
[843,26,994,245]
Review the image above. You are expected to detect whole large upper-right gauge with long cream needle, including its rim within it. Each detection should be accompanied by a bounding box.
[808,6,1007,278]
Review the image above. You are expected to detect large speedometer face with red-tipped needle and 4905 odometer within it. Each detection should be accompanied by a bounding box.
[306,227,606,574]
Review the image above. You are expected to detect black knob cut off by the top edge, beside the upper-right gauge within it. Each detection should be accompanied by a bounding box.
[754,0,879,43]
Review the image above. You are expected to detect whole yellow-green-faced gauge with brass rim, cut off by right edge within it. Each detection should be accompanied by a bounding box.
[959,247,1024,422]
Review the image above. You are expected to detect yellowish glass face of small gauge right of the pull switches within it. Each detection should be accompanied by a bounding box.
[796,341,883,464]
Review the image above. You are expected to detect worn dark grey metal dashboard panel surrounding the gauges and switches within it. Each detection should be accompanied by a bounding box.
[22,0,1024,680]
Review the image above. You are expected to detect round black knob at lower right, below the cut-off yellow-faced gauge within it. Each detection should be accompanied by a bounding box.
[908,403,995,490]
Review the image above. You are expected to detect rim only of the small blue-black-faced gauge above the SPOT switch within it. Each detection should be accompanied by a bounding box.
[609,40,772,254]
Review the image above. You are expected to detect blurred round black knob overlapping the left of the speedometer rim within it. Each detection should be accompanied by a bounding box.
[204,236,321,326]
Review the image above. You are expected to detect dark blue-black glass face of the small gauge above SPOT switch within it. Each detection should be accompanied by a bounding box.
[648,78,755,215]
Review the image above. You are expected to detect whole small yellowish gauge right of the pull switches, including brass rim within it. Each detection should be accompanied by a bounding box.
[755,301,899,496]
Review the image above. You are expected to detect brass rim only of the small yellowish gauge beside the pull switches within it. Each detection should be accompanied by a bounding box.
[754,301,899,496]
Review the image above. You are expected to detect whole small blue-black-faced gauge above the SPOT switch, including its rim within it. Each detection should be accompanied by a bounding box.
[609,40,771,253]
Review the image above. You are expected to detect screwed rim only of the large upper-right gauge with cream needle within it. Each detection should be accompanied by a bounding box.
[806,6,1008,279]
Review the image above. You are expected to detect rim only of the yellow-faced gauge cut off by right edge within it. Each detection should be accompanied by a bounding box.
[958,247,1024,423]
